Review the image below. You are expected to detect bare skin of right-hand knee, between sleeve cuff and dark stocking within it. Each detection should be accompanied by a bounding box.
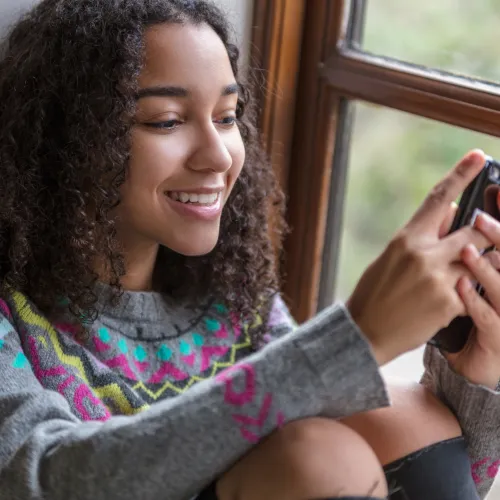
[342,379,462,465]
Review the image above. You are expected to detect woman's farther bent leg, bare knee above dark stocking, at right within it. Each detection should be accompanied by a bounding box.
[343,383,479,500]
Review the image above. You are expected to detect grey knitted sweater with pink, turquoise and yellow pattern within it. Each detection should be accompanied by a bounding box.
[0,292,500,500]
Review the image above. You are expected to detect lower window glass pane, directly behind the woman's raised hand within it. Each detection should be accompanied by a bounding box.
[336,102,500,300]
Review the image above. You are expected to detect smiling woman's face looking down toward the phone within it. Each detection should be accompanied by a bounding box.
[116,24,245,255]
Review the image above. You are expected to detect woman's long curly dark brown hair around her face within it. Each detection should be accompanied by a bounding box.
[0,0,285,340]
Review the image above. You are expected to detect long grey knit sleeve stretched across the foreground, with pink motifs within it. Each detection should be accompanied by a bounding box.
[0,306,388,500]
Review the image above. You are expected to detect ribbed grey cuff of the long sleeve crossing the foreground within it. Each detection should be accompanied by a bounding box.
[295,304,390,418]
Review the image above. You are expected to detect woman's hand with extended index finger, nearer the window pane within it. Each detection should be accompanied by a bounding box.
[347,151,492,365]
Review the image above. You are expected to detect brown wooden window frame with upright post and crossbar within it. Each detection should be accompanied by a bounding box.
[253,0,500,321]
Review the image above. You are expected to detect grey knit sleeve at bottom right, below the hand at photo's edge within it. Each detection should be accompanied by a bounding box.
[421,346,500,498]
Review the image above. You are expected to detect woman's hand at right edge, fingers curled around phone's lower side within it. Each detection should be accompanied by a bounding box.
[446,207,500,389]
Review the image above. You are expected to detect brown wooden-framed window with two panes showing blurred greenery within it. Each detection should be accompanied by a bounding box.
[285,0,500,321]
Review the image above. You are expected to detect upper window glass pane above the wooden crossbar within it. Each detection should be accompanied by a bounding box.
[363,0,500,81]
